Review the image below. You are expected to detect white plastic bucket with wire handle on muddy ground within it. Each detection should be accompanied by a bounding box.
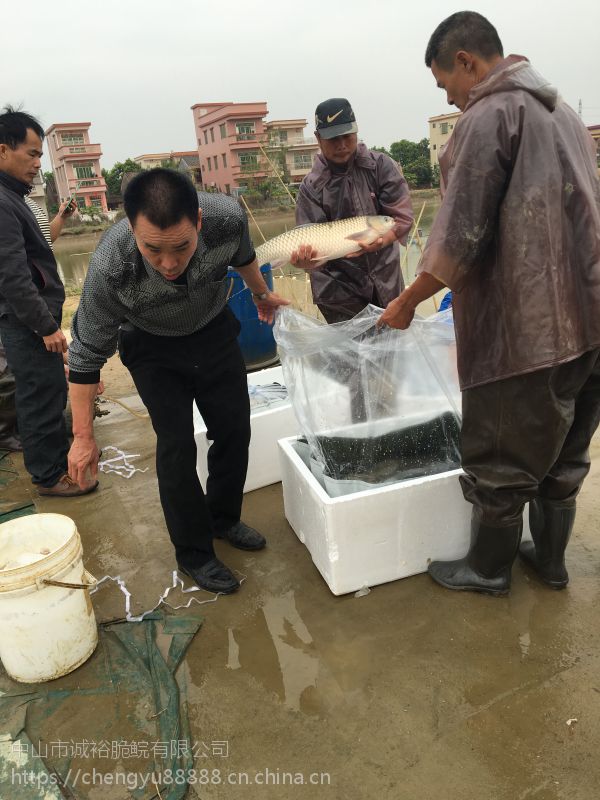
[0,514,98,683]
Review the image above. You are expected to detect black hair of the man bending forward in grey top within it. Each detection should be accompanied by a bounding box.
[123,167,199,230]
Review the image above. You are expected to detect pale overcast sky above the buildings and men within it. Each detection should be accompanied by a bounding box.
[5,0,600,169]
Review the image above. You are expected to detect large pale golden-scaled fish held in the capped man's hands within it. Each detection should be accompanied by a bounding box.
[256,216,395,267]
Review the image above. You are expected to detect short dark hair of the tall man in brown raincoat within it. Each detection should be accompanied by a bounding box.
[425,11,504,71]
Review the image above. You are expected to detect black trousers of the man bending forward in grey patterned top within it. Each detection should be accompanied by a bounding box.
[119,309,250,567]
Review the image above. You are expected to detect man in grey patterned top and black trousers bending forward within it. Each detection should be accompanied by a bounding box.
[69,169,287,593]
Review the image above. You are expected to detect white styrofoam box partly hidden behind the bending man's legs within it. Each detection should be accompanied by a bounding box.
[194,367,300,492]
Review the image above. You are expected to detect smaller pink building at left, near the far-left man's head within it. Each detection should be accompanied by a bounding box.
[46,122,108,212]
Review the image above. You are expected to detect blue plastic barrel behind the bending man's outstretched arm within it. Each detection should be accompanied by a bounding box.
[227,264,277,370]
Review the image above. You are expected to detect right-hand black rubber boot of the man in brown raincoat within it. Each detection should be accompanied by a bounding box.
[519,497,576,589]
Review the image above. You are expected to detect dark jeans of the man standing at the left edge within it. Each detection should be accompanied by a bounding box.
[0,325,69,488]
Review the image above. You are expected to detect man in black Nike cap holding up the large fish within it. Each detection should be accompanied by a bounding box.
[291,98,413,323]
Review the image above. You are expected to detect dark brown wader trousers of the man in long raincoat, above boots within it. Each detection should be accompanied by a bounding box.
[461,349,600,526]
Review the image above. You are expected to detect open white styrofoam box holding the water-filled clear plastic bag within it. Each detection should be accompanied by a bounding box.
[279,437,529,595]
